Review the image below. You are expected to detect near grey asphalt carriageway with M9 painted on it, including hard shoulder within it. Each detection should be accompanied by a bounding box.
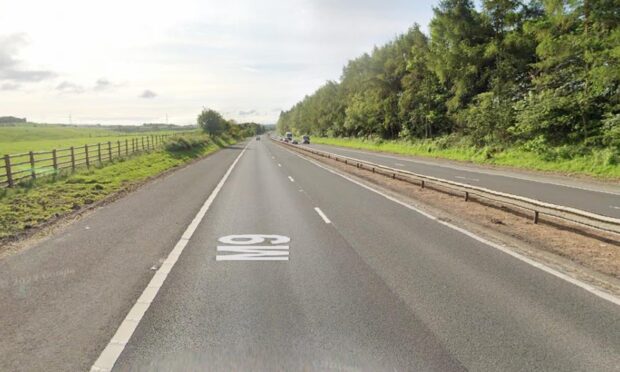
[0,140,620,371]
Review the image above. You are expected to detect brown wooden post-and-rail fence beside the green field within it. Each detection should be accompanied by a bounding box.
[0,134,170,187]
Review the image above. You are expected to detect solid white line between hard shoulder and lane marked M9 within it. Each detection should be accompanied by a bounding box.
[90,144,248,372]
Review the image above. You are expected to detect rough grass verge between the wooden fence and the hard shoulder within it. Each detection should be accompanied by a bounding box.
[0,133,235,241]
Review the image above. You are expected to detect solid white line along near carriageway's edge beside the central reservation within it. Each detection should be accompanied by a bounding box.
[286,144,620,306]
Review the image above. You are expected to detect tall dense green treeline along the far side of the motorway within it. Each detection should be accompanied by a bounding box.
[277,0,620,155]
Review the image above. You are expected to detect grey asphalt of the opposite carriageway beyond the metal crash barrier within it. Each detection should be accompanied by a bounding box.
[310,145,620,218]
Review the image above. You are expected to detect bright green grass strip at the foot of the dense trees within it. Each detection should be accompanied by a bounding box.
[312,138,620,180]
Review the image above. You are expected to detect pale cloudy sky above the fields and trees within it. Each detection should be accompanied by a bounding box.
[0,0,436,125]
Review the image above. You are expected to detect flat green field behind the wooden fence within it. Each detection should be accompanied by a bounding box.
[0,124,197,156]
